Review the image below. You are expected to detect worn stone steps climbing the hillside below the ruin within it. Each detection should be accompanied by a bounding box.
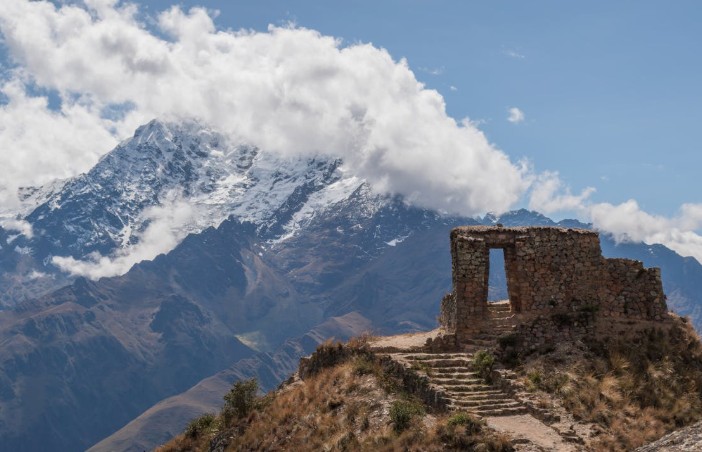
[393,352,527,416]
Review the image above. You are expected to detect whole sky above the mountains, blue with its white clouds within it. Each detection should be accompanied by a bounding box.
[0,0,702,259]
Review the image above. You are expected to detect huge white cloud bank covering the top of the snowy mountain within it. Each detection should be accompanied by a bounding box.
[0,0,528,219]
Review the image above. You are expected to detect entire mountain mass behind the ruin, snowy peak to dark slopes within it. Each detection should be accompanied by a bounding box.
[0,122,702,451]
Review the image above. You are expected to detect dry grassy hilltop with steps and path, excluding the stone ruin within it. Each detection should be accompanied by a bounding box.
[158,315,702,452]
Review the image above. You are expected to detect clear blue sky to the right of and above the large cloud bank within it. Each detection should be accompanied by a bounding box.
[133,0,702,215]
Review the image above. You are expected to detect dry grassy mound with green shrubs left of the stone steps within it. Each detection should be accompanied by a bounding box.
[158,344,512,452]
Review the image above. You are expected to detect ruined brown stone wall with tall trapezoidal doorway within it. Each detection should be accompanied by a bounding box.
[440,225,667,344]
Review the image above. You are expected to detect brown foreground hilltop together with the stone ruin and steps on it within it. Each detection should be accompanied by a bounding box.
[163,225,702,451]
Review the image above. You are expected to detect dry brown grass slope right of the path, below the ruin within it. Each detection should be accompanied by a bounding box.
[521,321,702,451]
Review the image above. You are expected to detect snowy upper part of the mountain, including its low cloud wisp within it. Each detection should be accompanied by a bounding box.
[0,120,438,307]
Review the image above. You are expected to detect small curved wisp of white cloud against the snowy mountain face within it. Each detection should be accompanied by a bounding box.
[52,195,196,279]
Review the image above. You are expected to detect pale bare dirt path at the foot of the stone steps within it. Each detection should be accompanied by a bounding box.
[485,414,579,452]
